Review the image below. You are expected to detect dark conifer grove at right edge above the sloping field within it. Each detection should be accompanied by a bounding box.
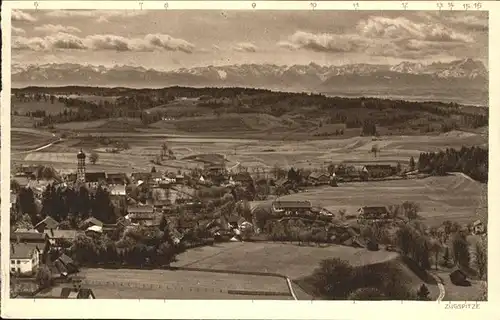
[418,146,488,182]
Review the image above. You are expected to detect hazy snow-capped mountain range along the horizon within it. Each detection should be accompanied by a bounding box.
[12,59,488,92]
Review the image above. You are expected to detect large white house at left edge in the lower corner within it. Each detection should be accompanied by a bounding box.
[10,243,40,274]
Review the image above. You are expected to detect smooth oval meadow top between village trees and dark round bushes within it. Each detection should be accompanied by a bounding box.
[173,242,397,280]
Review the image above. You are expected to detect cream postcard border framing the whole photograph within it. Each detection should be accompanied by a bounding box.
[1,1,500,320]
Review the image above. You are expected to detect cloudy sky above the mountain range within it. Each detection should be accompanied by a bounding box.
[12,10,488,70]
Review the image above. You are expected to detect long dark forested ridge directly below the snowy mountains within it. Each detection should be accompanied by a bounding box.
[18,87,488,135]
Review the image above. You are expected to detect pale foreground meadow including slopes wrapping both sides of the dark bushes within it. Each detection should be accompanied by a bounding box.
[174,242,439,300]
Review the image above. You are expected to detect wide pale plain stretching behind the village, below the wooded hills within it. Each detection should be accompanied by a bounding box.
[12,126,486,175]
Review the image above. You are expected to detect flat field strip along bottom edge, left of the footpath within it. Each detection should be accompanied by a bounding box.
[71,269,292,299]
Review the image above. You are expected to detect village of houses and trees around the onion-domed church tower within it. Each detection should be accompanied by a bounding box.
[5,142,486,298]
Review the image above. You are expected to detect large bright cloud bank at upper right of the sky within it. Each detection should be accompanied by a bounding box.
[357,17,473,42]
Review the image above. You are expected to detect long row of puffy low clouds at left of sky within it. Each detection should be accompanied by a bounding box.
[12,32,195,53]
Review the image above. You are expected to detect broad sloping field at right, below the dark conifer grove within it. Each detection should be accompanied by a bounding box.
[272,174,488,225]
